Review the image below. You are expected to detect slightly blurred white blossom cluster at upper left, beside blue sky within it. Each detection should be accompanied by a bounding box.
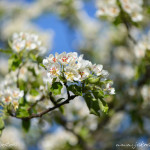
[11,32,46,53]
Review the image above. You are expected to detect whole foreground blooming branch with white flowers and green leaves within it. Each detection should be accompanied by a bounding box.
[0,32,115,134]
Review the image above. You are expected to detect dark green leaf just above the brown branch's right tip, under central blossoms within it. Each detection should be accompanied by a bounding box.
[67,84,82,96]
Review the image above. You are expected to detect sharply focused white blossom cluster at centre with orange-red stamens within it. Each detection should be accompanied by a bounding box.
[43,52,115,94]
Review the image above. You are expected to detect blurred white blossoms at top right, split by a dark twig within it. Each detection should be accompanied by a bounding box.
[97,0,143,22]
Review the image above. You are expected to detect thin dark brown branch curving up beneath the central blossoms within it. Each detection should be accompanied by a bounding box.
[9,95,77,120]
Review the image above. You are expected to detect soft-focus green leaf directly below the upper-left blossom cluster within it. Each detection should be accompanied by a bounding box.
[8,55,22,71]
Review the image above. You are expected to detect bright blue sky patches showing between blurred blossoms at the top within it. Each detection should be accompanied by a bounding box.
[31,0,96,53]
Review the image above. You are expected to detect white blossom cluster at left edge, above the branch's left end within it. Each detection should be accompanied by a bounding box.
[0,87,24,110]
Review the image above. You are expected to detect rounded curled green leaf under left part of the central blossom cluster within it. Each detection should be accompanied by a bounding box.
[50,82,63,95]
